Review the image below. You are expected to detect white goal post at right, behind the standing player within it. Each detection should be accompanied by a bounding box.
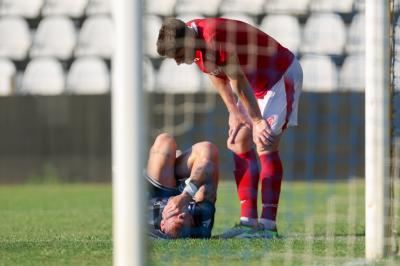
[365,0,392,259]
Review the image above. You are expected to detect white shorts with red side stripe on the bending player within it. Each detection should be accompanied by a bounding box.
[238,59,303,135]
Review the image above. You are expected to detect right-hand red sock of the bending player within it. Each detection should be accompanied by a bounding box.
[260,151,283,224]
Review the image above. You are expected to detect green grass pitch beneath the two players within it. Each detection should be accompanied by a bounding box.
[0,180,400,266]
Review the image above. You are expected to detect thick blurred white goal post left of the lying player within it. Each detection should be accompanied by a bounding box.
[111,0,146,266]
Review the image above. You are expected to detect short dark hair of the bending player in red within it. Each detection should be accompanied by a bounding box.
[157,18,187,57]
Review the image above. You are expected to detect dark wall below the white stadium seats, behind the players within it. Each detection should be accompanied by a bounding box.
[0,92,364,183]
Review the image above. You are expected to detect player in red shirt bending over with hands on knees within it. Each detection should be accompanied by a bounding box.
[157,18,303,238]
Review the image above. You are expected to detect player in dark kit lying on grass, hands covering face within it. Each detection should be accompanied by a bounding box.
[146,133,218,239]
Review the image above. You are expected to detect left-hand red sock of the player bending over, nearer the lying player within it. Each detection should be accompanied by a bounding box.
[233,149,259,224]
